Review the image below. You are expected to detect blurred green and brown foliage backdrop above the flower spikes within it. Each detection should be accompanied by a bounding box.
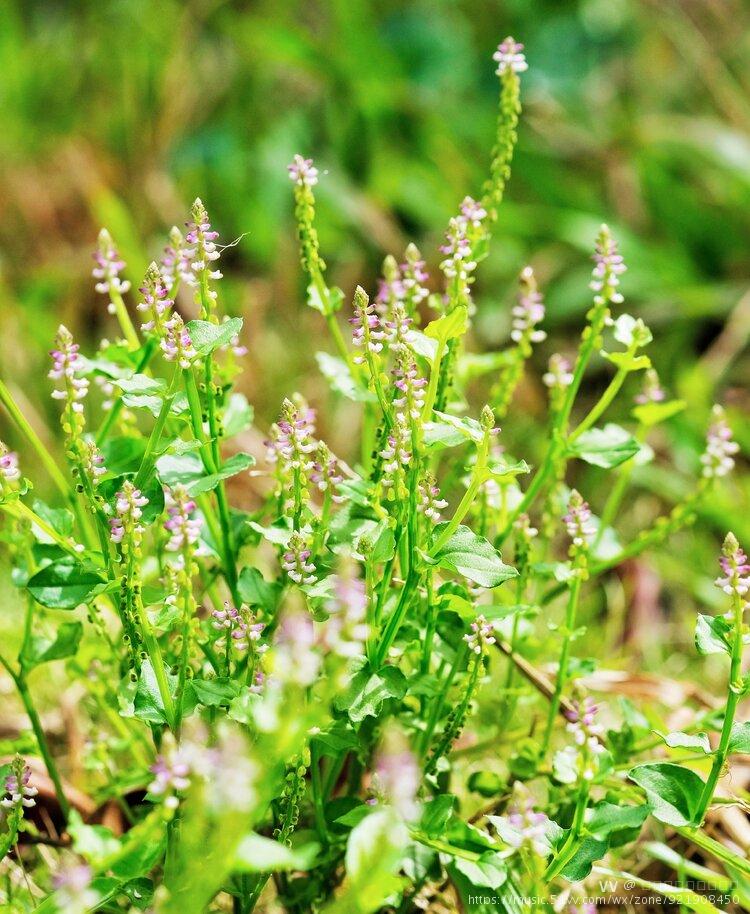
[0,0,750,660]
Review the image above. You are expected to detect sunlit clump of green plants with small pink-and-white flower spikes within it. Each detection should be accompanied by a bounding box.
[0,38,750,914]
